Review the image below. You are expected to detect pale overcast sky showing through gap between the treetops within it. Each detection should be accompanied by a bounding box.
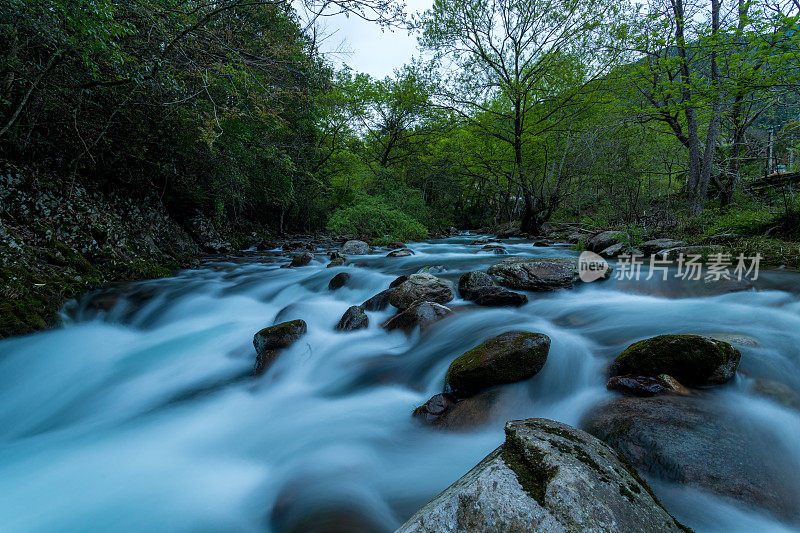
[312,0,433,78]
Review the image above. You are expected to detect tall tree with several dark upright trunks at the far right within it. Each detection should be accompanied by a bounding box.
[618,0,797,214]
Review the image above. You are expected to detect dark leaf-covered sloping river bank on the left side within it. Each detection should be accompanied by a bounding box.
[0,163,272,338]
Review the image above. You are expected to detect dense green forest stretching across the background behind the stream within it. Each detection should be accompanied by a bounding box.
[0,0,800,240]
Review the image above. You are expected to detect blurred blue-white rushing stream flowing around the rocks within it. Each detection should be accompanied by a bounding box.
[0,236,800,532]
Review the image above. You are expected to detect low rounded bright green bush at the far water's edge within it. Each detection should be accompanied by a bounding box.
[328,197,428,244]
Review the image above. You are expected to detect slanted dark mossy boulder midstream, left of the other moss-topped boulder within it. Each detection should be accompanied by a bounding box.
[445,331,550,396]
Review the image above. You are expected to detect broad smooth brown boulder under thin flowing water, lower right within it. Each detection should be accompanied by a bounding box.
[582,395,800,520]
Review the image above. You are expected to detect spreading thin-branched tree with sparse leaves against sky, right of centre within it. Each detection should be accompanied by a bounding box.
[418,0,619,232]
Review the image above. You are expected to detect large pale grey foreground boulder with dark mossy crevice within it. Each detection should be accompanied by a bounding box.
[397,418,683,533]
